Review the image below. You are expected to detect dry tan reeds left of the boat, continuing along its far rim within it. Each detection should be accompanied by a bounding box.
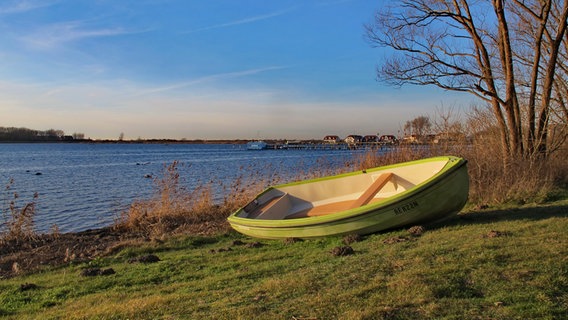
[114,156,348,239]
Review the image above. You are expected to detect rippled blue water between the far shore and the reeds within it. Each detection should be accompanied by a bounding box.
[0,144,361,232]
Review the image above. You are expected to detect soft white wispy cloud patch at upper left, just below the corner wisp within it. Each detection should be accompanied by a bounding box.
[23,21,140,49]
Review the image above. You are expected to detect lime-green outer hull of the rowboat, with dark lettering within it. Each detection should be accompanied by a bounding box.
[228,157,469,239]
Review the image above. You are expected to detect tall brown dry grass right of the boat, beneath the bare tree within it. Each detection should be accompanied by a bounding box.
[457,108,568,205]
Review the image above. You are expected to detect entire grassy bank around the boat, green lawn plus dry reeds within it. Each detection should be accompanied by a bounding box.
[0,146,568,319]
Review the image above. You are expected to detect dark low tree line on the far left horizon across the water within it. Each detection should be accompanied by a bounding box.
[0,127,85,142]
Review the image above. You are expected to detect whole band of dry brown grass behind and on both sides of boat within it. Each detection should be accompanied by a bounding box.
[115,129,568,238]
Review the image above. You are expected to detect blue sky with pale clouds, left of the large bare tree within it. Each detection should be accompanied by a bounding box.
[0,0,471,139]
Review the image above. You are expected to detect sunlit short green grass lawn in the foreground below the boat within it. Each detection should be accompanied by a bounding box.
[0,200,568,319]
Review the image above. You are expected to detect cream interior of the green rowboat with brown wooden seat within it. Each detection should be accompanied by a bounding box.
[238,161,446,220]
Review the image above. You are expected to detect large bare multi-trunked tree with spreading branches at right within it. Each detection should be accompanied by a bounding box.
[366,0,568,167]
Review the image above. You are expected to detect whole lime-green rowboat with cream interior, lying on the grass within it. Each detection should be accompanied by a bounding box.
[228,156,469,239]
